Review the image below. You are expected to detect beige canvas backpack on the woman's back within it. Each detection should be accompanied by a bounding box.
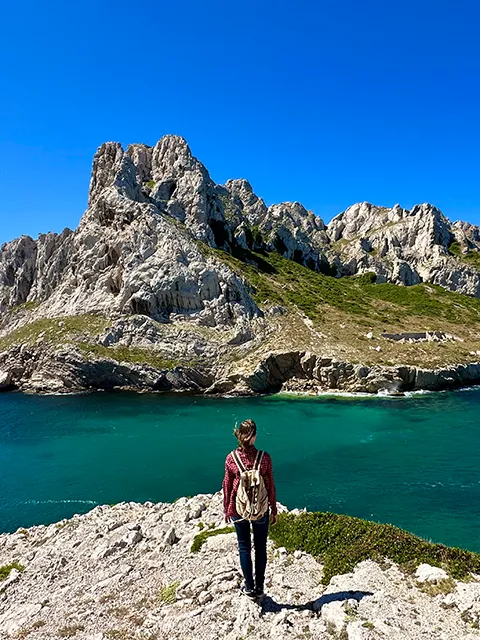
[232,451,268,520]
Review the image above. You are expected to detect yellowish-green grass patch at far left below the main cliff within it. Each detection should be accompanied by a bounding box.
[0,314,109,351]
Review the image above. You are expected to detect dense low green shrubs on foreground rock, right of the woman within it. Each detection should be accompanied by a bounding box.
[270,513,480,584]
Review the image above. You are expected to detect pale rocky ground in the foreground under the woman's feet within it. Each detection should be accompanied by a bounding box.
[0,493,480,640]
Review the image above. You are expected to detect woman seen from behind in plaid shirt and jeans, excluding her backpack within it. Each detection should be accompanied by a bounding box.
[223,420,277,600]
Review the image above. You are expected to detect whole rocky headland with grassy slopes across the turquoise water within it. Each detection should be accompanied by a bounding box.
[0,135,480,394]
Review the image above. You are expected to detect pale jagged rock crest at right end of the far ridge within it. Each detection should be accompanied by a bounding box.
[327,202,480,297]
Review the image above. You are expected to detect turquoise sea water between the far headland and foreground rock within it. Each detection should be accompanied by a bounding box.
[0,389,480,551]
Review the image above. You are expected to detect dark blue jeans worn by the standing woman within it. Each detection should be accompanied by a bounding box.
[232,509,270,591]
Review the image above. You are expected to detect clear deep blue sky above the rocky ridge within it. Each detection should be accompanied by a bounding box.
[0,0,480,242]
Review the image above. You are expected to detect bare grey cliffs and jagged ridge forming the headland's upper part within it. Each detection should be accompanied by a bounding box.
[0,136,480,326]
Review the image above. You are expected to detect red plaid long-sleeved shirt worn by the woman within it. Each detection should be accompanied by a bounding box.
[223,446,277,518]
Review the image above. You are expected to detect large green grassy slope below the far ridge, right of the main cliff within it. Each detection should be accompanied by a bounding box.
[203,248,480,324]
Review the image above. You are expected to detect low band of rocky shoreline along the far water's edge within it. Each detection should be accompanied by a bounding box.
[0,345,480,395]
